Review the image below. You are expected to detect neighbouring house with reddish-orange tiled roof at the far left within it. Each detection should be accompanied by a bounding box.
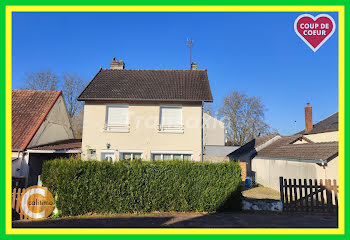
[12,90,78,186]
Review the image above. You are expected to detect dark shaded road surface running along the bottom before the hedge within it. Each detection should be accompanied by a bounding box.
[12,212,338,228]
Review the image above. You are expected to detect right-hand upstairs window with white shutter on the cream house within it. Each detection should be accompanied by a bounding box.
[159,106,183,133]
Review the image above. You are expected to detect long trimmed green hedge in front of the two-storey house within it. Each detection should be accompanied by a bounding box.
[42,159,242,216]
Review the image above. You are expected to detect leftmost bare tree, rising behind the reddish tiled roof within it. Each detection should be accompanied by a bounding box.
[23,70,58,91]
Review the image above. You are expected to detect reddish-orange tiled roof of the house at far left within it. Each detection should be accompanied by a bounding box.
[12,90,61,150]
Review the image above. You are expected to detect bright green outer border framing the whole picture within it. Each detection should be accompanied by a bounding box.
[0,0,350,240]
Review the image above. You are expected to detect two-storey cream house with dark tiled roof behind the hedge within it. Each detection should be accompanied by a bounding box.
[78,60,213,161]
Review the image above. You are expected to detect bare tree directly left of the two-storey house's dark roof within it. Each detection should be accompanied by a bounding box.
[62,73,85,119]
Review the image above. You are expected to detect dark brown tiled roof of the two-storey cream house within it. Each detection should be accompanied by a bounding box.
[78,69,213,102]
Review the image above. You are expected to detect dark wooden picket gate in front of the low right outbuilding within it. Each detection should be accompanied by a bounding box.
[280,177,338,213]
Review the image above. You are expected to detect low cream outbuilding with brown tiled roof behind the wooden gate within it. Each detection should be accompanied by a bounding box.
[252,136,338,190]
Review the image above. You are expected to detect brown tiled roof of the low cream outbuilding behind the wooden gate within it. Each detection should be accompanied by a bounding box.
[257,135,338,161]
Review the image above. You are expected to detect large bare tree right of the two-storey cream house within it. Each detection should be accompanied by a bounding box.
[219,91,273,145]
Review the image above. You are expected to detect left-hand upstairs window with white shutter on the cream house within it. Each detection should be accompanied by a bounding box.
[105,104,129,132]
